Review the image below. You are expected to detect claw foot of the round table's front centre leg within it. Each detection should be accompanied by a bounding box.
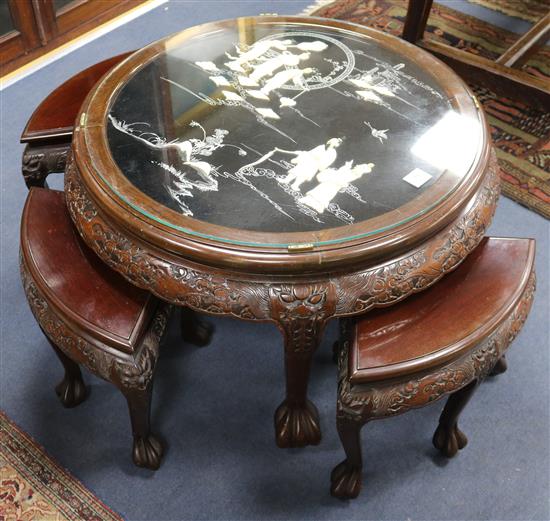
[275,400,321,448]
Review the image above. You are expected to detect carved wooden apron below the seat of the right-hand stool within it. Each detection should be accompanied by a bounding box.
[338,273,535,421]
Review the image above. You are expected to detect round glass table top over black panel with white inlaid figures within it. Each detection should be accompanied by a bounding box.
[85,17,484,247]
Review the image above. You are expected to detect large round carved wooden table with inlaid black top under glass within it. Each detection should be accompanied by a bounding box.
[65,16,498,447]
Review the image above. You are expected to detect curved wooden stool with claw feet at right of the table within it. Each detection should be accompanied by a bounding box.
[331,238,535,498]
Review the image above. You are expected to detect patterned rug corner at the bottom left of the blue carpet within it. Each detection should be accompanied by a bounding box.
[0,411,122,521]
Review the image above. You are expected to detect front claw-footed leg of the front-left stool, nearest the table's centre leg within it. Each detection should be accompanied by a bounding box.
[122,382,163,470]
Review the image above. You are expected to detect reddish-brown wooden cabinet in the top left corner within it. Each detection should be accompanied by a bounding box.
[0,0,145,75]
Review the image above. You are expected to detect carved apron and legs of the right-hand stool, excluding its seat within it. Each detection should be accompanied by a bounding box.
[331,273,535,498]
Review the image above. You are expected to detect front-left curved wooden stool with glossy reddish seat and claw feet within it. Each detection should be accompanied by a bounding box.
[20,188,171,469]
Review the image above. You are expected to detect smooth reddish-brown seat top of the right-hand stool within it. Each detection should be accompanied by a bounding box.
[349,239,531,384]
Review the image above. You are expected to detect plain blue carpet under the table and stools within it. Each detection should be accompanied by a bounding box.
[0,1,550,521]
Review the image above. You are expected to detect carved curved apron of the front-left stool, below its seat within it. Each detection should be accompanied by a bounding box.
[20,250,171,390]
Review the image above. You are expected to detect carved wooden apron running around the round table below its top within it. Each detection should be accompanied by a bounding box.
[65,147,499,324]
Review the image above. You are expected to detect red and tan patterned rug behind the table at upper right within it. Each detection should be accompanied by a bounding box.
[307,0,550,218]
